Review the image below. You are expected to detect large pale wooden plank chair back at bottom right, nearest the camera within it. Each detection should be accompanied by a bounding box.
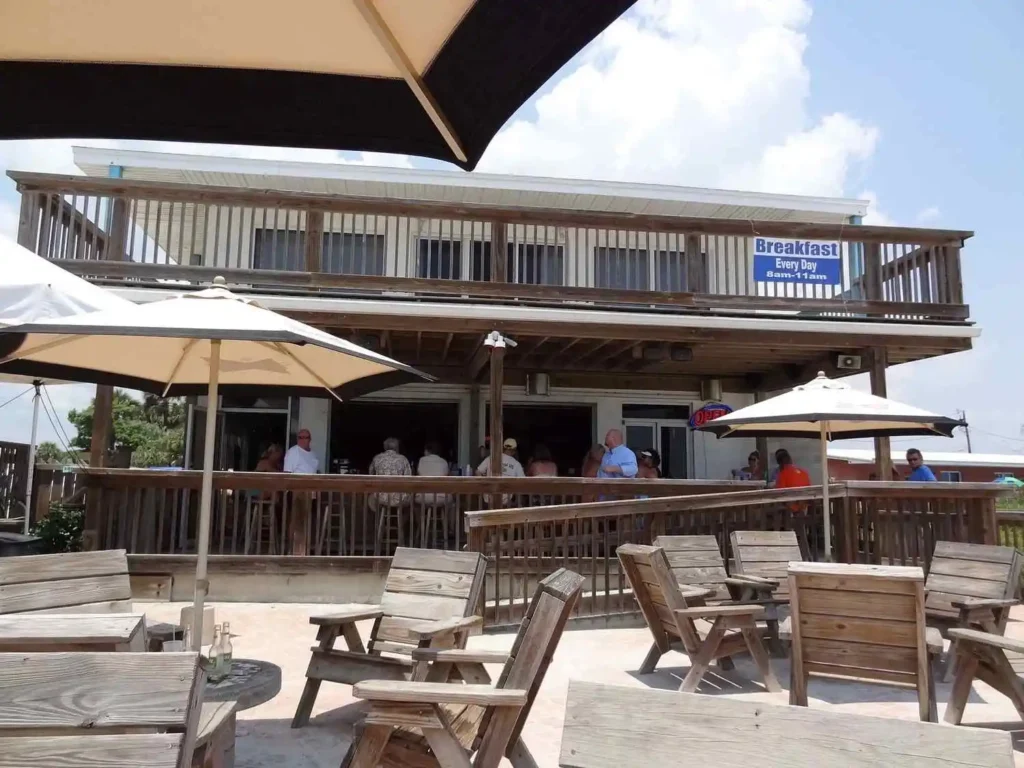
[558,680,1014,768]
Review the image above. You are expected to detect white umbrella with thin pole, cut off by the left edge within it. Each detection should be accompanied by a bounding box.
[0,234,134,534]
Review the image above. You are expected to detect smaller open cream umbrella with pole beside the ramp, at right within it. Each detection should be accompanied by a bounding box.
[700,372,963,557]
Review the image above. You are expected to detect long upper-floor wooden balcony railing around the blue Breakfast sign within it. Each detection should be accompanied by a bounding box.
[9,172,971,322]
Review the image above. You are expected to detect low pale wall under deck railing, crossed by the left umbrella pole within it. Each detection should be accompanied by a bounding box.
[128,555,391,603]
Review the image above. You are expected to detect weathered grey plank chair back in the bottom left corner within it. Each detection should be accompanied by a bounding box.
[0,653,206,768]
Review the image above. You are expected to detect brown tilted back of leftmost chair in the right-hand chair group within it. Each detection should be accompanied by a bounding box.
[615,544,703,653]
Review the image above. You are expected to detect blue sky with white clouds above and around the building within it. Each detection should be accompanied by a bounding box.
[0,0,1024,453]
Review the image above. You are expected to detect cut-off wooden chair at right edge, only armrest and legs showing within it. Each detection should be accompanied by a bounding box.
[943,629,1024,725]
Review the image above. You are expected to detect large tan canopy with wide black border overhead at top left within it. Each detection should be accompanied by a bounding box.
[0,0,635,170]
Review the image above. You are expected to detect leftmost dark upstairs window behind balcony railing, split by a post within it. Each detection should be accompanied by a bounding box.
[253,229,385,274]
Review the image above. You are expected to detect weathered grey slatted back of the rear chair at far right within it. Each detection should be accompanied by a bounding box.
[925,542,1021,618]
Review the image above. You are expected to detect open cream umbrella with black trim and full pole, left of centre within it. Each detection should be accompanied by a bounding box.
[0,278,431,649]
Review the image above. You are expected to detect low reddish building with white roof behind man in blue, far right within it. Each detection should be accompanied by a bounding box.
[828,444,1024,482]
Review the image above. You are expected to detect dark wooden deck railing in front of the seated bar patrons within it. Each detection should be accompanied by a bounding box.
[76,469,758,556]
